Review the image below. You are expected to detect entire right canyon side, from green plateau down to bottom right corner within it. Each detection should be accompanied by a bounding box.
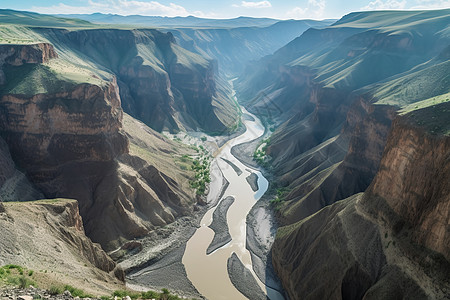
[253,10,450,299]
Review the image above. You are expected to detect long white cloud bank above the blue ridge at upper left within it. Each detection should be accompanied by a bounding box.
[32,0,199,17]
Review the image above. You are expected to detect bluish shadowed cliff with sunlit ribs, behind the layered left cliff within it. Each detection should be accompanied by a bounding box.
[40,29,237,132]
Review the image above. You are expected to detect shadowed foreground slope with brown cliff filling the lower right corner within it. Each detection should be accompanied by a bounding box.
[273,106,450,299]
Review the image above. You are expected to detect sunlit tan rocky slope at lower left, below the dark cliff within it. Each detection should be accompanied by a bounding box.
[0,199,124,293]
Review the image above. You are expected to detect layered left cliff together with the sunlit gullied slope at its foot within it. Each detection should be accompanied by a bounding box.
[0,42,200,256]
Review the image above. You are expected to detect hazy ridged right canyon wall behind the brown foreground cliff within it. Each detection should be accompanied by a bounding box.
[237,10,449,224]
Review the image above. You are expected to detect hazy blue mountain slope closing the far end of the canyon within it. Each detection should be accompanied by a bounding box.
[169,20,332,76]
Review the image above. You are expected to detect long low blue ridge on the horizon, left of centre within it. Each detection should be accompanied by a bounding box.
[55,13,279,28]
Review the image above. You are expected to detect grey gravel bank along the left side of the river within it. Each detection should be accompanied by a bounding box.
[119,135,229,299]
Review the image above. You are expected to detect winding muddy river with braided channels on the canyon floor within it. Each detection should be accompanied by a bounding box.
[182,109,278,300]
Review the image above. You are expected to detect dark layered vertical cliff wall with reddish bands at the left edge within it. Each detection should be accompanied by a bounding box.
[0,81,128,168]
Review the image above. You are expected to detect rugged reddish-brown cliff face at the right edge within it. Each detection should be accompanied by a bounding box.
[365,117,450,261]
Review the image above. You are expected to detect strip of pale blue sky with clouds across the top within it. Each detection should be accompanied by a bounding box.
[0,0,450,19]
